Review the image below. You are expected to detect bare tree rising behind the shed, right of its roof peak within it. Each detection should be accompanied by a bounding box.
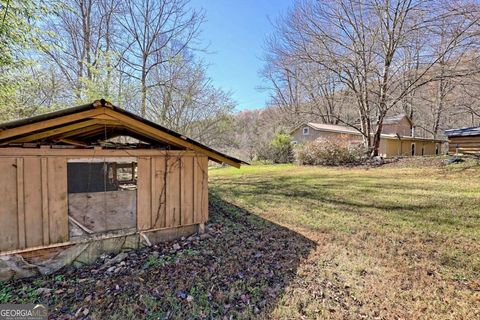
[121,0,204,116]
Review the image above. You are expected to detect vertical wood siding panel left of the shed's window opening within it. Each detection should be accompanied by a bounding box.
[0,157,68,251]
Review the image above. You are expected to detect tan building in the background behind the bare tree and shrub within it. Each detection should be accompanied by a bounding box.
[292,115,444,157]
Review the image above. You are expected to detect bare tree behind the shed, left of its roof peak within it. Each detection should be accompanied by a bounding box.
[42,0,119,100]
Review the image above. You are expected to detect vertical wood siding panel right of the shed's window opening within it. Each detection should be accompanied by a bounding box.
[137,155,208,230]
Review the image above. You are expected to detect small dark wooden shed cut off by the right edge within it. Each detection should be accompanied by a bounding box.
[445,127,480,154]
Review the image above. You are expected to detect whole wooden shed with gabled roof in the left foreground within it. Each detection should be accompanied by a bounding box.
[0,100,246,280]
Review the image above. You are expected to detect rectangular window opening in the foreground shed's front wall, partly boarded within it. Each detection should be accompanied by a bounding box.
[67,158,137,240]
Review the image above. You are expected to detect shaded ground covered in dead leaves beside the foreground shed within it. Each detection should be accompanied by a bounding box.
[0,196,315,319]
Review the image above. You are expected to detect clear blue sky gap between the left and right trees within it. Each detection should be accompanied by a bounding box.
[191,0,292,110]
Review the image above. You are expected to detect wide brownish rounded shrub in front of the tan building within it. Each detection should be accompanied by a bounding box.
[295,139,365,166]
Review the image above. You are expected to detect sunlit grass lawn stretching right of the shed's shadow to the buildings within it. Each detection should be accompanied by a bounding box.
[210,158,480,319]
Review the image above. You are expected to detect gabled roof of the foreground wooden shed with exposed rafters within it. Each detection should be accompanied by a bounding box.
[0,99,248,168]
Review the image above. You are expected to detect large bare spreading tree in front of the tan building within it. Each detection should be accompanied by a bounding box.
[264,0,479,156]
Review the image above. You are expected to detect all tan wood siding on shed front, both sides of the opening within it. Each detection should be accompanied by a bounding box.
[0,148,208,252]
